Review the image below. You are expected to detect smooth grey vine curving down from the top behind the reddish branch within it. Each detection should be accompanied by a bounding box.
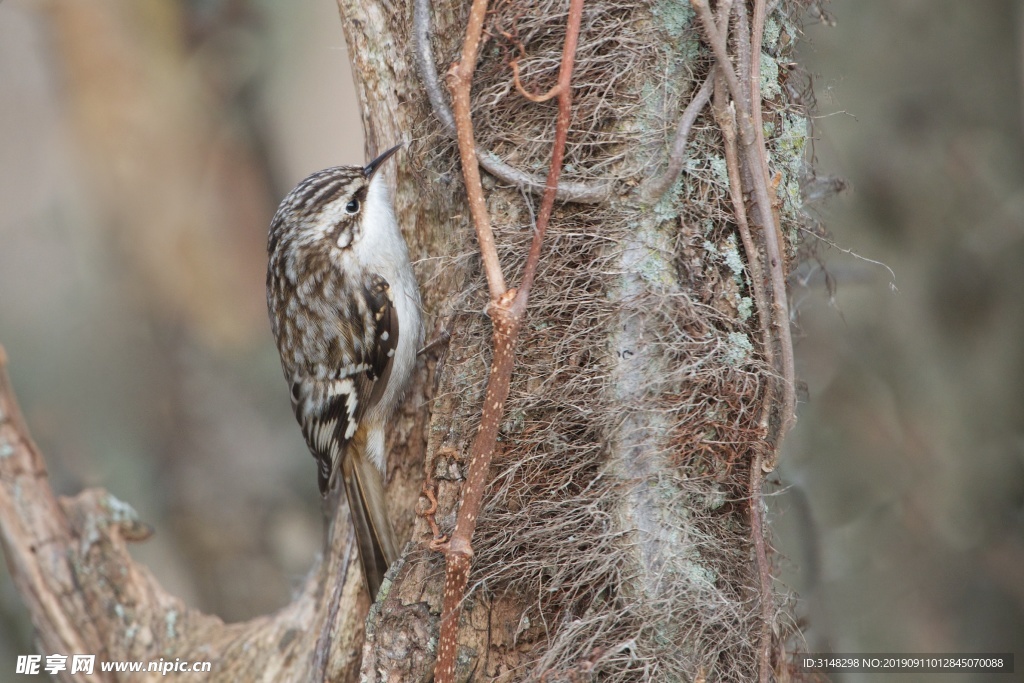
[413,0,614,204]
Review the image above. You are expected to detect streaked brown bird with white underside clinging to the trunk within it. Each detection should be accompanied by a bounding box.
[266,144,423,599]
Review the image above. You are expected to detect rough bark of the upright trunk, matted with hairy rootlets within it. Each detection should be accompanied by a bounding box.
[339,0,804,681]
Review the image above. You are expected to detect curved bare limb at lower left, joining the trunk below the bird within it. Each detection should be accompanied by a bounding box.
[0,347,366,681]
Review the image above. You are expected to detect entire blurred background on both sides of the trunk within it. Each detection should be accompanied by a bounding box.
[0,0,1024,681]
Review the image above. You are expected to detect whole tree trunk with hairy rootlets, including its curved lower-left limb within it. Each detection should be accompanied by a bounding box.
[0,0,808,681]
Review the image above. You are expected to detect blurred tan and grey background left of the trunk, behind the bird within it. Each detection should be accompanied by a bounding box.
[0,0,364,681]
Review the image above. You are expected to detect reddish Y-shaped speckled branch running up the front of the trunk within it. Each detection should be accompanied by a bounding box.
[434,0,584,683]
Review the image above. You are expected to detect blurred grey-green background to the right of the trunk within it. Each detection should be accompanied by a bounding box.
[772,0,1024,681]
